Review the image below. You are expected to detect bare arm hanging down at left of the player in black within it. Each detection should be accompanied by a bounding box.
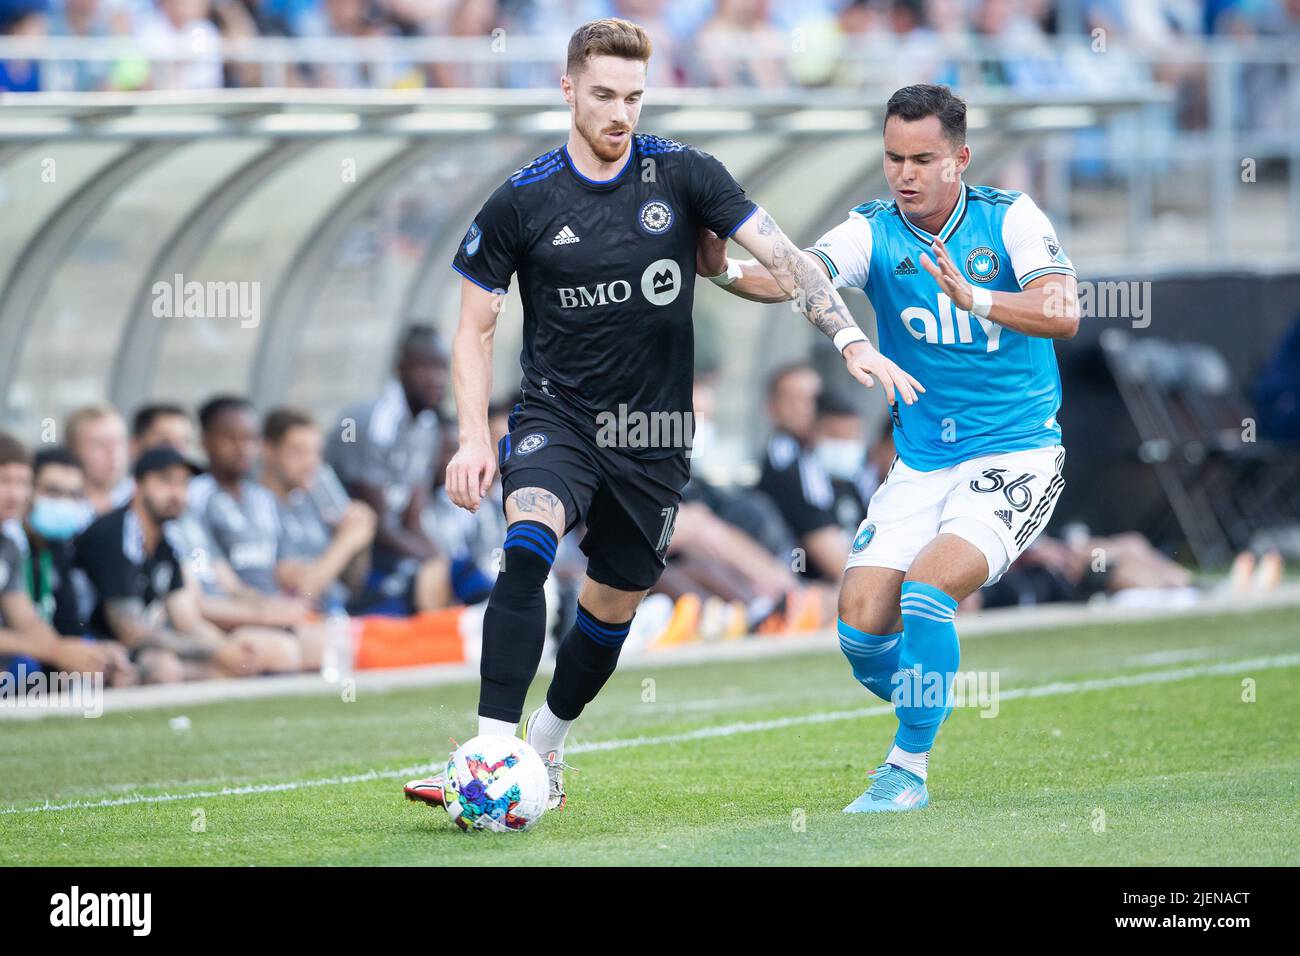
[446,278,506,511]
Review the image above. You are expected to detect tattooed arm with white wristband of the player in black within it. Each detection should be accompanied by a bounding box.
[732,209,926,405]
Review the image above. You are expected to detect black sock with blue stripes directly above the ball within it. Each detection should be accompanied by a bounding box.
[478,522,558,723]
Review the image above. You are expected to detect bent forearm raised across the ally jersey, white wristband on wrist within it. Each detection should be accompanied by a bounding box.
[920,239,1079,338]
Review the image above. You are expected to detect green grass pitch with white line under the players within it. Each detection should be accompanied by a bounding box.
[0,609,1300,866]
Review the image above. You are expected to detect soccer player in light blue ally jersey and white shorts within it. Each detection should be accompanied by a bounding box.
[699,85,1078,813]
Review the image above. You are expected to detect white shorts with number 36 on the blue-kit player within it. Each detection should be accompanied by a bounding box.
[845,445,1065,585]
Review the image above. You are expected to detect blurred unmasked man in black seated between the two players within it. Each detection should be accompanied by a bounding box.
[758,363,849,581]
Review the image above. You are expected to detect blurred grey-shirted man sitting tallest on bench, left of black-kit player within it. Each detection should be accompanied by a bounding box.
[325,325,451,615]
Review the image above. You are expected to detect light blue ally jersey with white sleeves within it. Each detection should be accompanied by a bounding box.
[809,185,1074,471]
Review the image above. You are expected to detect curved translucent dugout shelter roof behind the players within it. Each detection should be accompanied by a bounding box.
[0,90,1160,438]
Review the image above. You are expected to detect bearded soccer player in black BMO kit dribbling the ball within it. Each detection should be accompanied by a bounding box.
[406,18,924,808]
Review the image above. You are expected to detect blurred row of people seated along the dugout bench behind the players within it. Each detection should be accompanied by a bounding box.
[0,325,1258,684]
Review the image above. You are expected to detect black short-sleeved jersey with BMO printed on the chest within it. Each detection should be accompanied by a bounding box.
[452,134,758,458]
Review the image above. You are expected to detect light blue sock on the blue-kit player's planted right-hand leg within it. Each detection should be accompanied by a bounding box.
[894,581,961,753]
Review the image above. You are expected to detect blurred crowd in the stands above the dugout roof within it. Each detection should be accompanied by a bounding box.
[0,0,1300,108]
